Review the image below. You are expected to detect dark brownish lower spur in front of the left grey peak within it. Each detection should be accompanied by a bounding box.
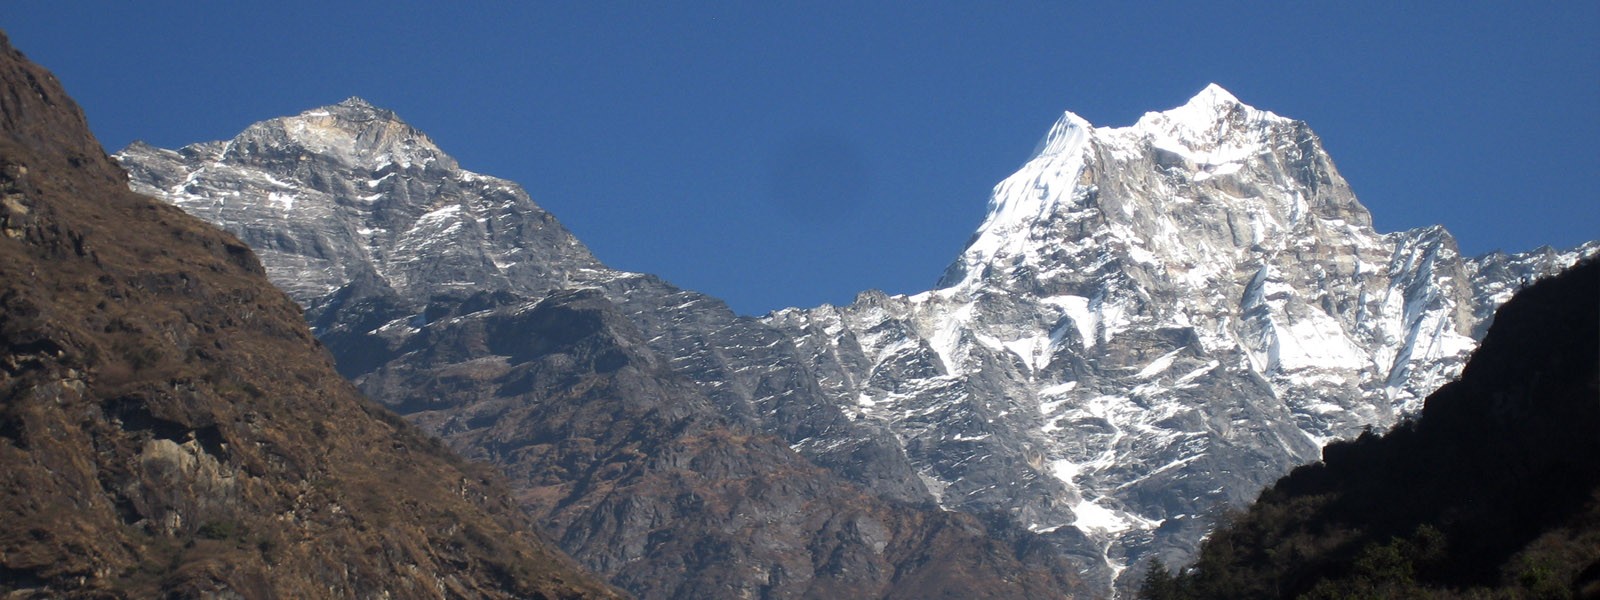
[363,290,1070,598]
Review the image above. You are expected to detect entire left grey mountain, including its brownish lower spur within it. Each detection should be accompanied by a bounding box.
[118,99,1078,598]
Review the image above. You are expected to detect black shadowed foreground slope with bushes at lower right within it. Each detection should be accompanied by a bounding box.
[1164,261,1600,598]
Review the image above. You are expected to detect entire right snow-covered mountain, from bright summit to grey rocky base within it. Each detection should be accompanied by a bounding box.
[768,85,1576,592]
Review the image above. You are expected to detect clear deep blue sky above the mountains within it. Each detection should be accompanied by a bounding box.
[0,0,1600,314]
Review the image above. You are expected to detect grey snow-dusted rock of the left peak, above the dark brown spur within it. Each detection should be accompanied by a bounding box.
[117,98,928,502]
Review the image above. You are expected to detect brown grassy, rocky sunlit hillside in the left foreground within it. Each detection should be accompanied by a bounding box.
[0,35,622,598]
